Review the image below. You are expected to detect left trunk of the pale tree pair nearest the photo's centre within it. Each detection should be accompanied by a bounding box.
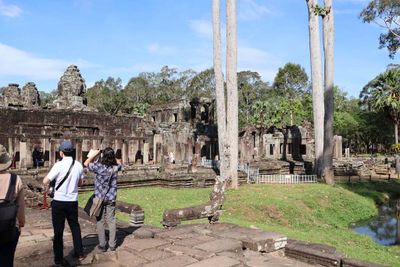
[212,0,228,181]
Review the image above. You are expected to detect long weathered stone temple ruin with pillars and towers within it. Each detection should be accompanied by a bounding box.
[0,66,324,186]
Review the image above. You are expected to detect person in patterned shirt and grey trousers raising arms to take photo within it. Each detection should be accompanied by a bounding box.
[83,147,122,252]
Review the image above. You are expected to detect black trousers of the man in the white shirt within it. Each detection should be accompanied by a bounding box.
[51,200,83,262]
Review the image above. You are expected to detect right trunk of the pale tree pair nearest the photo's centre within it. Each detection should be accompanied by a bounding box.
[226,0,239,188]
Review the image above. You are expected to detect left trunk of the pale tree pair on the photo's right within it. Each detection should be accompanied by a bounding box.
[306,0,324,180]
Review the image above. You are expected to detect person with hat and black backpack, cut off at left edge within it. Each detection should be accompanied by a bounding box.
[0,145,25,267]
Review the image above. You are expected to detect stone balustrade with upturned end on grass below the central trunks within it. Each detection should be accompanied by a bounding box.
[161,179,225,227]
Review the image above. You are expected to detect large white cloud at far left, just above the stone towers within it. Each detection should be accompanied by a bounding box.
[0,43,96,80]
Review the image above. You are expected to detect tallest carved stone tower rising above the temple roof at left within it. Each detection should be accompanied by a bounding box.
[51,65,88,110]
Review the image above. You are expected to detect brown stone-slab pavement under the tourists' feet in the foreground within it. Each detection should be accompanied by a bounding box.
[15,209,316,267]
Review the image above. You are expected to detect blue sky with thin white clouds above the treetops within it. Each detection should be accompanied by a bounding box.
[0,0,398,97]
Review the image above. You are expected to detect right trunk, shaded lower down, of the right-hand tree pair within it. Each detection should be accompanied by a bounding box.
[322,0,335,185]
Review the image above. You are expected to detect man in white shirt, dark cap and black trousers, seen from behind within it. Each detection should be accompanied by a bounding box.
[43,141,84,265]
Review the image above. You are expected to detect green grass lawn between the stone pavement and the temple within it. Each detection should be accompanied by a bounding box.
[79,181,400,266]
